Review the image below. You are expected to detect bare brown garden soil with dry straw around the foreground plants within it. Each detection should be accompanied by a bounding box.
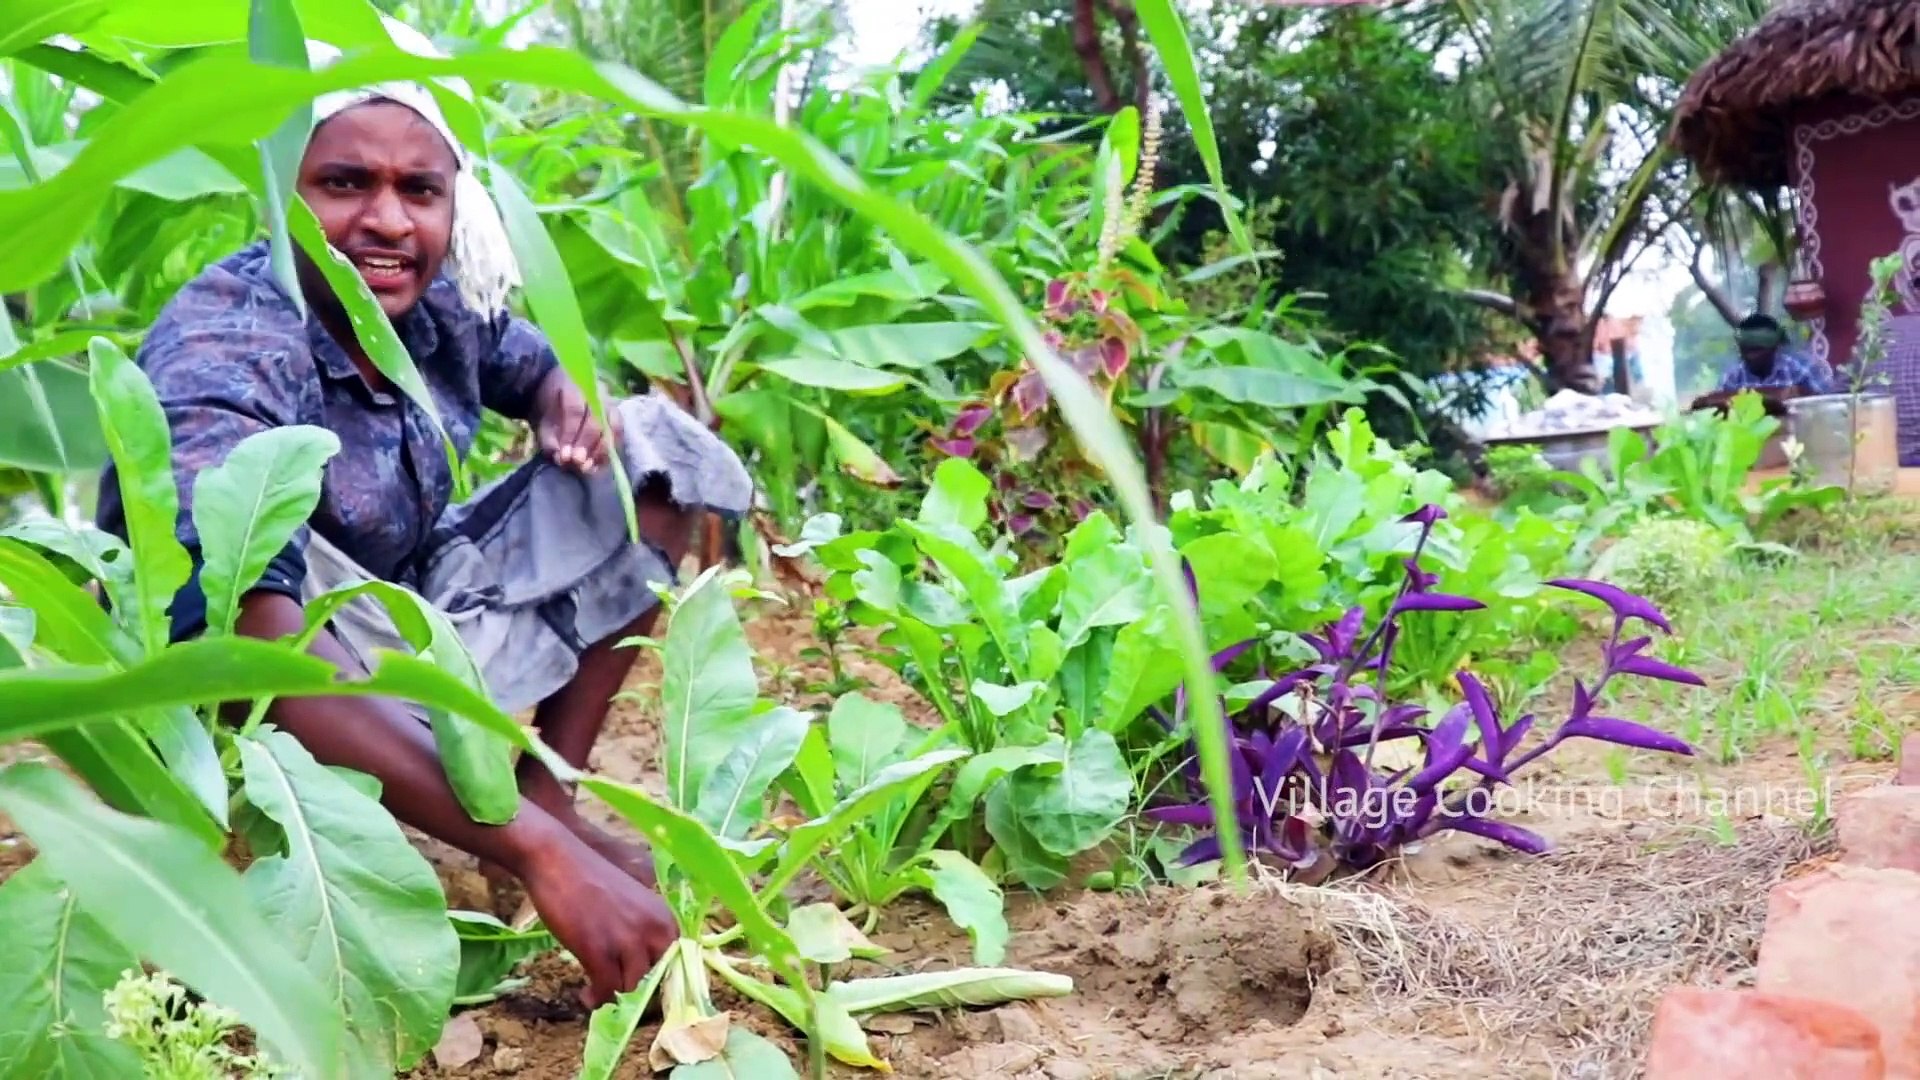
[0,609,1866,1080]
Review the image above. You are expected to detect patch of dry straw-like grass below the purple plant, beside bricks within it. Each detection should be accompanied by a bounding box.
[1271,822,1832,1078]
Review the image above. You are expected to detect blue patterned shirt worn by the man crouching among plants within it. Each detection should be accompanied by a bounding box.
[96,242,559,634]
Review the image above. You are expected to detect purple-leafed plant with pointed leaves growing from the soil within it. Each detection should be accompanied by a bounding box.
[1144,505,1703,869]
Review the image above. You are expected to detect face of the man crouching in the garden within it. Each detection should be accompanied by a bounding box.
[296,102,457,319]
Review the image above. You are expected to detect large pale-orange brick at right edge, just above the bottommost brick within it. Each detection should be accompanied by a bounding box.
[1755,863,1920,1080]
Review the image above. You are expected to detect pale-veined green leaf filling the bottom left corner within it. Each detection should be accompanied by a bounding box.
[0,861,140,1080]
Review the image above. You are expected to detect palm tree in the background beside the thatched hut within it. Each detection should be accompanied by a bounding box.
[1405,0,1768,392]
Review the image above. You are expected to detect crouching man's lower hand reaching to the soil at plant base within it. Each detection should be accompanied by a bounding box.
[520,822,680,1009]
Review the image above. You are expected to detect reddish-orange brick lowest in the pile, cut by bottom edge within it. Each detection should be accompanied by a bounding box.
[1645,986,1887,1080]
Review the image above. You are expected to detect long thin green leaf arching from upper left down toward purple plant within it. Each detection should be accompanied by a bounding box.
[0,39,1250,880]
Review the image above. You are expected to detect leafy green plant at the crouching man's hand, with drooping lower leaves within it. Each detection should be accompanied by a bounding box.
[580,569,1071,1076]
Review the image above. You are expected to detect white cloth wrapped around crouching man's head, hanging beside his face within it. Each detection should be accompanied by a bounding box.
[307,17,520,317]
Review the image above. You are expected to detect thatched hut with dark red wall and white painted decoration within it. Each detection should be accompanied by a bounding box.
[1674,0,1920,453]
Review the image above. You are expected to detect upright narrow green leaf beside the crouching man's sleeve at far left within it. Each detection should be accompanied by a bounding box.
[86,338,194,655]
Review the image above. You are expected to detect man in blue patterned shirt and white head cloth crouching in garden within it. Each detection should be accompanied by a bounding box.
[100,48,751,1005]
